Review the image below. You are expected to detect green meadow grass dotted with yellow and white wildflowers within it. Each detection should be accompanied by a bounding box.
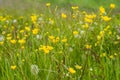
[0,3,120,80]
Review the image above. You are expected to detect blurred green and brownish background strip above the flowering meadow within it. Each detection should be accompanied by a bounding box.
[0,0,120,14]
